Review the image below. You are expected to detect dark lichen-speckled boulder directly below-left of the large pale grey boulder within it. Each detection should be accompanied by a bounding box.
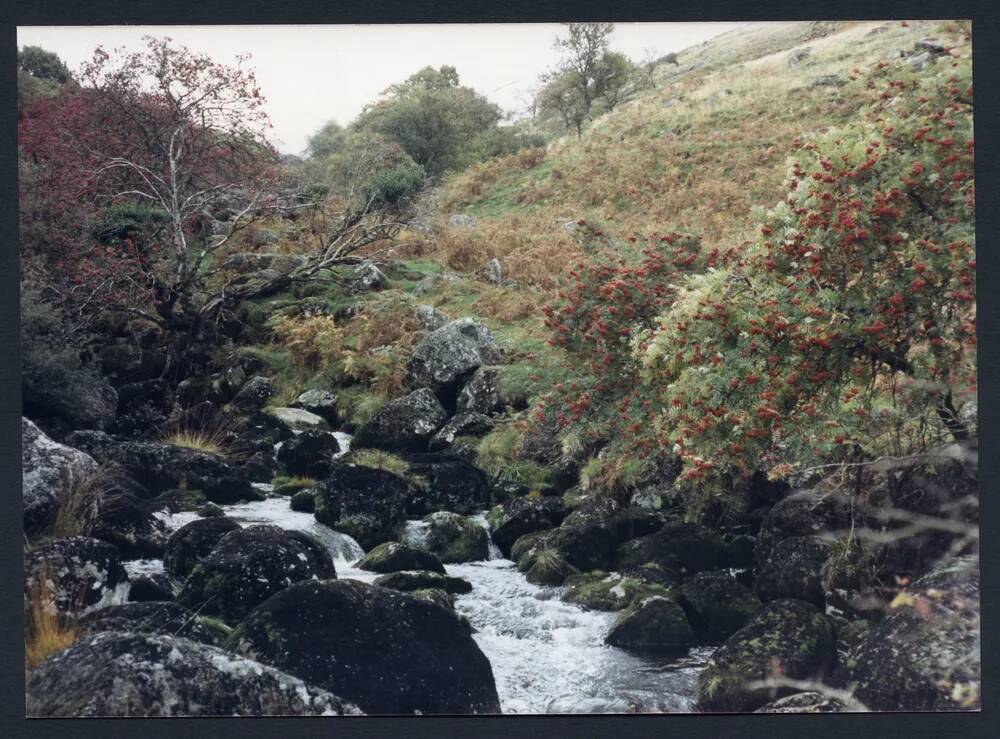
[351,388,448,452]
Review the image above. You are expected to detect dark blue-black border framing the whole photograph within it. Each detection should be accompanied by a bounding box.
[0,0,1000,739]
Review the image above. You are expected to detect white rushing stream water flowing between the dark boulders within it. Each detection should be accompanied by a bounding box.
[152,434,712,713]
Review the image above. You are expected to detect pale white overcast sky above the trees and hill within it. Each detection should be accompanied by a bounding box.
[17,23,741,154]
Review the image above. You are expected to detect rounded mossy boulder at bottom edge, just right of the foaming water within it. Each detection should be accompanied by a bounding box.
[695,600,836,712]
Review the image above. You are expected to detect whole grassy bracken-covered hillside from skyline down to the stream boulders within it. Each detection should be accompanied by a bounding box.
[232,22,960,486]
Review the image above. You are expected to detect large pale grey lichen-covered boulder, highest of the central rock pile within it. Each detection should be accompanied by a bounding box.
[406,318,500,408]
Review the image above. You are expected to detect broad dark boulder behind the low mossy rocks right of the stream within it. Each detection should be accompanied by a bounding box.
[615,523,726,575]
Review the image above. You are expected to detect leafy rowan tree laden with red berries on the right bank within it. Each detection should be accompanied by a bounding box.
[536,52,976,492]
